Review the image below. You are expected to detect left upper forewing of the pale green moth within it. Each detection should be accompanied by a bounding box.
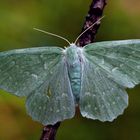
[0,47,63,96]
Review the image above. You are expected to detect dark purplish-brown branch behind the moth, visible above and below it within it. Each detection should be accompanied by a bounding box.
[40,0,106,140]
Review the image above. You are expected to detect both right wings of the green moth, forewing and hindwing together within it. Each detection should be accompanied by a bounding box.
[80,40,140,121]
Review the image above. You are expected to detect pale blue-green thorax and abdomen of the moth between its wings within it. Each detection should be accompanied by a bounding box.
[66,45,81,104]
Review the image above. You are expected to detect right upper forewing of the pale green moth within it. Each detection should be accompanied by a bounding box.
[84,40,140,88]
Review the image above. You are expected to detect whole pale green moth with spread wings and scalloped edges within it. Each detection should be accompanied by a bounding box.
[0,18,140,125]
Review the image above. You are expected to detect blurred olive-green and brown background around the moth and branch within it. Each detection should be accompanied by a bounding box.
[0,0,140,140]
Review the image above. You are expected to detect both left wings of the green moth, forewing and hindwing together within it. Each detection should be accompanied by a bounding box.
[0,47,75,125]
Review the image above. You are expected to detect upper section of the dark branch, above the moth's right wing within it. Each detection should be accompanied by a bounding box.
[77,0,107,46]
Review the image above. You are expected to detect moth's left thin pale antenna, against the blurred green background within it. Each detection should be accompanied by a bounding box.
[33,28,71,45]
